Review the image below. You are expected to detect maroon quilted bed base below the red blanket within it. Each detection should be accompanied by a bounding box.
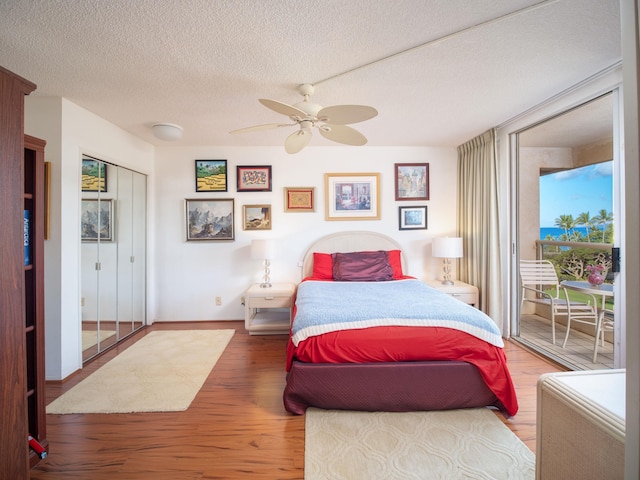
[284,360,504,415]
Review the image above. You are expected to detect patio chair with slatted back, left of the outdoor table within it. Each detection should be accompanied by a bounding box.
[520,260,597,348]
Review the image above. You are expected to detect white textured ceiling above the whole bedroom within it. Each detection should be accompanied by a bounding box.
[0,0,621,146]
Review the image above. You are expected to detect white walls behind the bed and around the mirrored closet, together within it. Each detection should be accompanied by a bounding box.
[25,96,457,380]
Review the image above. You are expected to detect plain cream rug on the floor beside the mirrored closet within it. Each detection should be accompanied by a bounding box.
[47,330,235,414]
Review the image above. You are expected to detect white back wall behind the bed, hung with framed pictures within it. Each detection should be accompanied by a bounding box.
[151,147,457,321]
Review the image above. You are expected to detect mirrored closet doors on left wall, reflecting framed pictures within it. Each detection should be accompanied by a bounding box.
[81,156,147,361]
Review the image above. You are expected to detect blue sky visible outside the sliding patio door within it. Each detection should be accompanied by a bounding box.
[540,162,613,227]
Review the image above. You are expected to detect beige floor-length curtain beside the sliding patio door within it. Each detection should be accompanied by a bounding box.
[458,129,503,327]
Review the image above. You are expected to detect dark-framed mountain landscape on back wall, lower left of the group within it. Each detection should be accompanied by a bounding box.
[185,198,235,242]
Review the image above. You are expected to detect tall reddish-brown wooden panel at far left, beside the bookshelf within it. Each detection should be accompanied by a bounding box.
[0,67,36,480]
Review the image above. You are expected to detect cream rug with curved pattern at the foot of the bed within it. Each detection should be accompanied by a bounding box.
[304,408,535,480]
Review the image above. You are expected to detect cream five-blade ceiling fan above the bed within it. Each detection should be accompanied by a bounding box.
[230,83,378,153]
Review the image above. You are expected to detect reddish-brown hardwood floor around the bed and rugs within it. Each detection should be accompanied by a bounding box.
[31,321,561,480]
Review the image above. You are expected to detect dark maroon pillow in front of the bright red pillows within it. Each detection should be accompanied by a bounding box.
[332,250,393,282]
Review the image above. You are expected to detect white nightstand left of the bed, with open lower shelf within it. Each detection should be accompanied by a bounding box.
[244,283,296,335]
